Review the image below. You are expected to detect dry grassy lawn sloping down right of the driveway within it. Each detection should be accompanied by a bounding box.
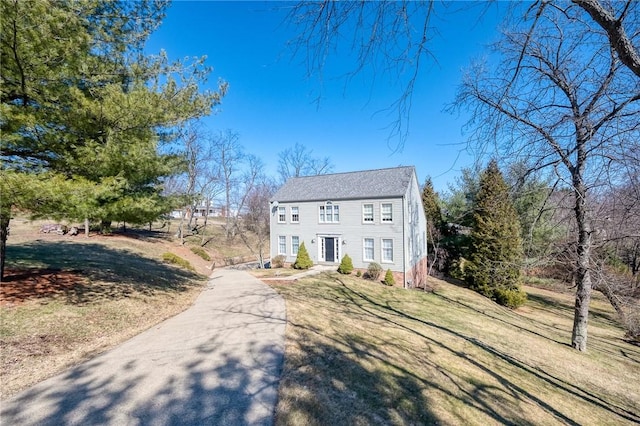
[272,274,640,425]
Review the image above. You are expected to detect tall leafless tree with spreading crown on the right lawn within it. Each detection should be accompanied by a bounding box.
[457,3,640,351]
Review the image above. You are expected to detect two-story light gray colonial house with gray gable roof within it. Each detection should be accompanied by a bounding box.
[270,167,427,287]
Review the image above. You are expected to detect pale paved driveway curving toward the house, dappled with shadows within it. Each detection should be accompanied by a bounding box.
[0,269,286,426]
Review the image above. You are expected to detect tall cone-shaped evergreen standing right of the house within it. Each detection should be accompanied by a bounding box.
[465,160,526,308]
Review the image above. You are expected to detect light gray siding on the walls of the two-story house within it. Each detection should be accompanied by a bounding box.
[270,168,427,284]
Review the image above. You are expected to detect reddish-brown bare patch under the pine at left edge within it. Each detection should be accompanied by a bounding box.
[0,268,85,306]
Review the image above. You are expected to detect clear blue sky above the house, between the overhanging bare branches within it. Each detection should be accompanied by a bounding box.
[147,1,500,191]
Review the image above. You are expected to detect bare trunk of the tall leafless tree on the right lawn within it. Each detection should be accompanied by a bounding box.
[571,172,591,351]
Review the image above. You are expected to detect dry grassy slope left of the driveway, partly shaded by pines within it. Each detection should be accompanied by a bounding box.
[0,218,248,399]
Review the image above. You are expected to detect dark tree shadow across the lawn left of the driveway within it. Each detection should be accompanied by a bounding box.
[1,241,204,305]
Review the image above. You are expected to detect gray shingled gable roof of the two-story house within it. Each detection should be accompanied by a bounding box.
[271,166,415,202]
